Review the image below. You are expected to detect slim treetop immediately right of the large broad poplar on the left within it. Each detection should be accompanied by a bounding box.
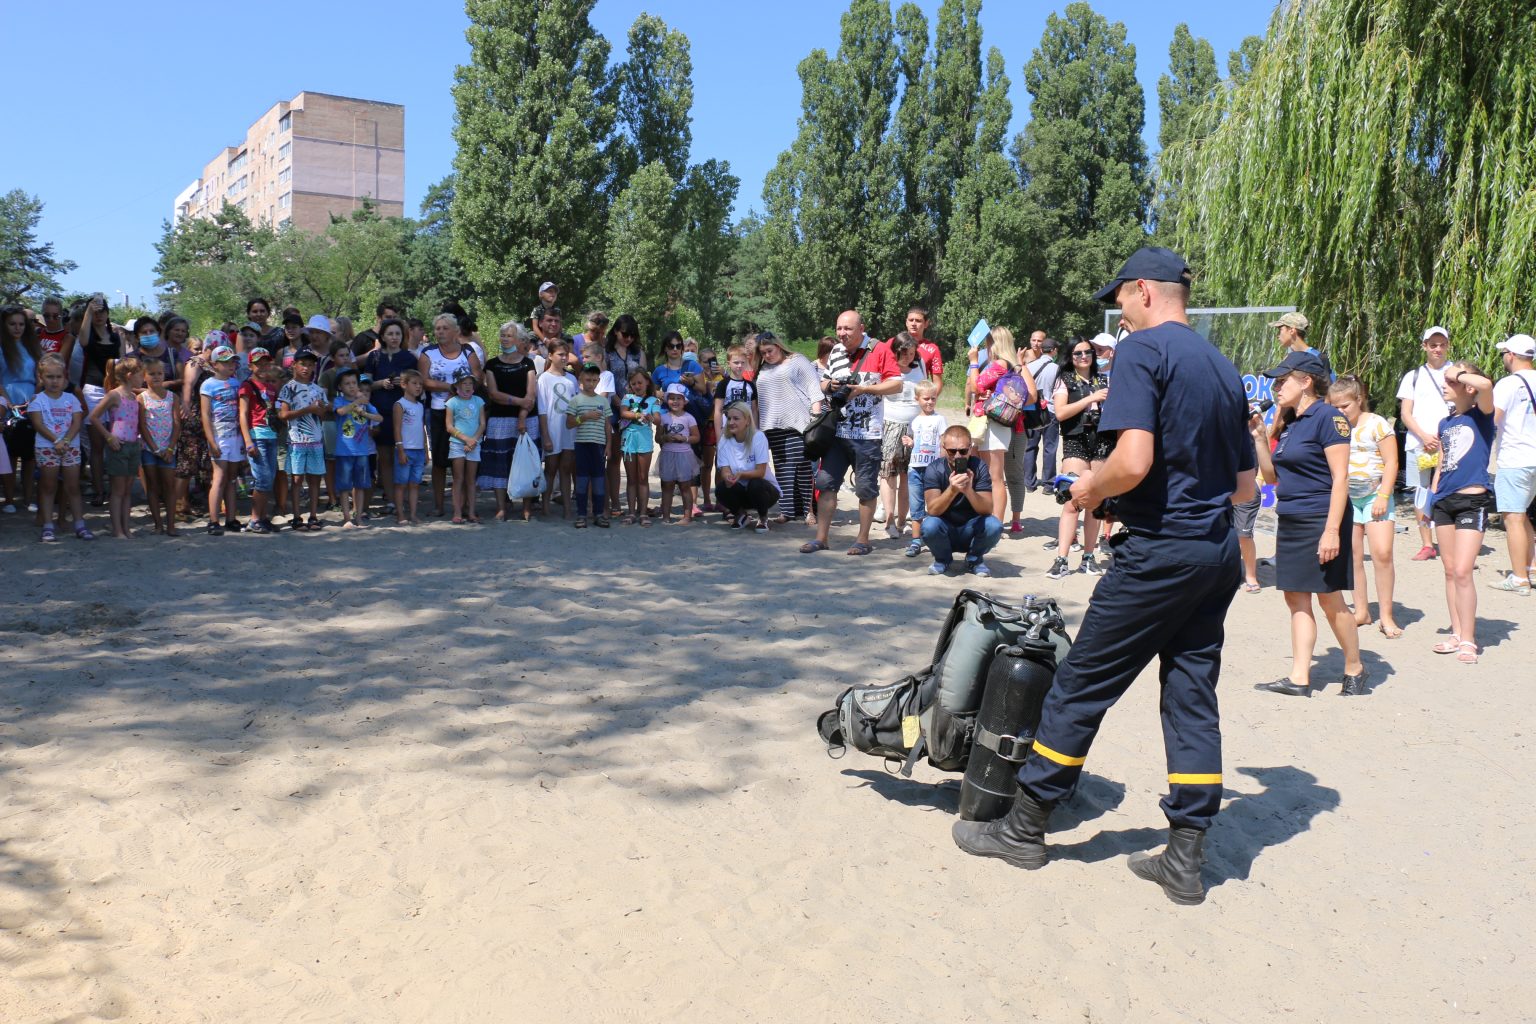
[614,14,693,190]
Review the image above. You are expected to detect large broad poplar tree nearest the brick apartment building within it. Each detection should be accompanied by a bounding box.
[452,0,614,316]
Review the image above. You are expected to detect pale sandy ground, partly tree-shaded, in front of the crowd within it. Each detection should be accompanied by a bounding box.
[0,496,1536,1024]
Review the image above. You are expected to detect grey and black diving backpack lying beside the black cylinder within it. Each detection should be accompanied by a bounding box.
[816,590,1069,777]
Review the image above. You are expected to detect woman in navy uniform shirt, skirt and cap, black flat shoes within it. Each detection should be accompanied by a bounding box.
[1253,352,1367,697]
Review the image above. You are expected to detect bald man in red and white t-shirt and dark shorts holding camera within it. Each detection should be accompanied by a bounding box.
[800,310,902,554]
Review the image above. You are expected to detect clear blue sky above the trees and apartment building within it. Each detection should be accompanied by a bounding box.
[0,0,1273,306]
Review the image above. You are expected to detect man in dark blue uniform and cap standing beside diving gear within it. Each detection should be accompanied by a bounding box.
[954,247,1256,904]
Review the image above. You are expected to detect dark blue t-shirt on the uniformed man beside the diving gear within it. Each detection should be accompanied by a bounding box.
[1098,324,1255,557]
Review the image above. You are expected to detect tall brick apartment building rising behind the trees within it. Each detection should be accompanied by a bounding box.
[172,92,406,232]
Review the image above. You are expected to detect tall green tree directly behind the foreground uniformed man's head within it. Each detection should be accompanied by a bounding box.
[1014,2,1150,340]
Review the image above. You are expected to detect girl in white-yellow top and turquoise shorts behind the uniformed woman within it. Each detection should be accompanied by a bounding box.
[1329,375,1402,640]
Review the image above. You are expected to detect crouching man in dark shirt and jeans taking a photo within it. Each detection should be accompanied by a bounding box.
[923,424,1003,577]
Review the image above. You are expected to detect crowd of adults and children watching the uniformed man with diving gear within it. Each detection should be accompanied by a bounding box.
[0,282,1536,666]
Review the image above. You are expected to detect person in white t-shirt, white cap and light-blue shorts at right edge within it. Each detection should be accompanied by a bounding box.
[1488,335,1536,597]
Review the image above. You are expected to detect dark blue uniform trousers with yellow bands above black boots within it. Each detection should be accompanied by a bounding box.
[1018,531,1243,829]
